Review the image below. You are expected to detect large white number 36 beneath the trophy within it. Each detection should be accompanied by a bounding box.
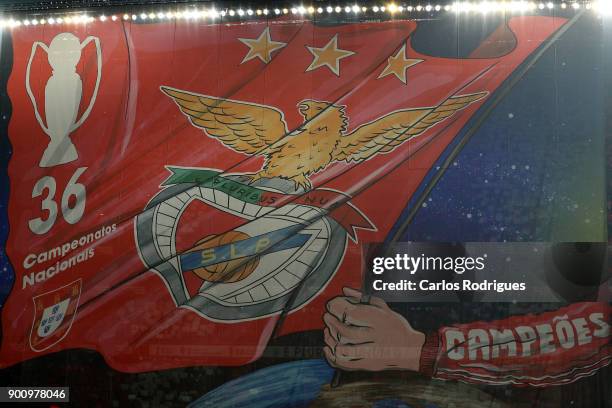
[28,167,87,235]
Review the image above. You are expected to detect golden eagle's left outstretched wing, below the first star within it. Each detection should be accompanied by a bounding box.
[161,86,287,154]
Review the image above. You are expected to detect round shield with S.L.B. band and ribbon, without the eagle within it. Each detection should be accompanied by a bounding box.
[135,167,374,321]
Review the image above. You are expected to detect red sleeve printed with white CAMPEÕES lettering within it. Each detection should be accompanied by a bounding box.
[420,302,612,386]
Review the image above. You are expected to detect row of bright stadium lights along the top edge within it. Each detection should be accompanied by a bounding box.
[0,0,612,29]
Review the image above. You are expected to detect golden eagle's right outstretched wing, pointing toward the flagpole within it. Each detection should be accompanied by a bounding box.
[332,92,488,162]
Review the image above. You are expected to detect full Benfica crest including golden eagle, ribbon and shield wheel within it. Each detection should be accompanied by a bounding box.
[135,87,486,321]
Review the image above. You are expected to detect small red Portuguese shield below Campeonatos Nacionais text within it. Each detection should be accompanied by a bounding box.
[30,279,81,351]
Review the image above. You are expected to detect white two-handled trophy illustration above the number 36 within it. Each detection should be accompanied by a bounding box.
[26,33,102,167]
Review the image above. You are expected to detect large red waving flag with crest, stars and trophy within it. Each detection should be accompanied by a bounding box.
[0,12,566,372]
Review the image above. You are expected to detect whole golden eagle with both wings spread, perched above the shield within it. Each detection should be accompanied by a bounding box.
[161,86,488,190]
